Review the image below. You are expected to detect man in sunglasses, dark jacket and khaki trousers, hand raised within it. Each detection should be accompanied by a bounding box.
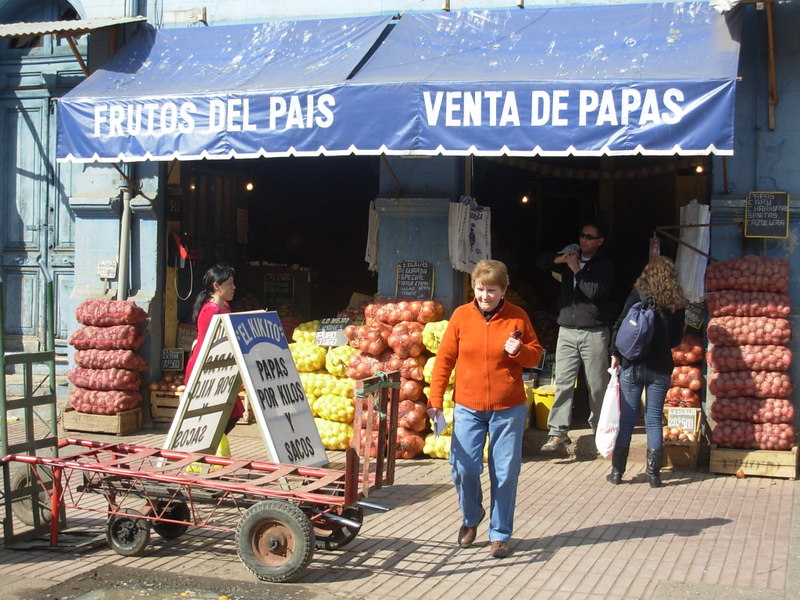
[536,223,614,452]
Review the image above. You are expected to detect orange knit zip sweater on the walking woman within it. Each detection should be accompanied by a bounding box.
[428,300,542,410]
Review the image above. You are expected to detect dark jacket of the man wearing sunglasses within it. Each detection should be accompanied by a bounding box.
[536,247,614,329]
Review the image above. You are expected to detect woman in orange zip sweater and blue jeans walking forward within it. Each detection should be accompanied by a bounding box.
[428,260,542,558]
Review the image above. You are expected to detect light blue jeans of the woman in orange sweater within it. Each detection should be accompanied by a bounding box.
[450,403,527,542]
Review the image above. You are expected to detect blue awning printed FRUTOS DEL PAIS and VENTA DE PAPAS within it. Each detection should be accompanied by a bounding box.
[57,2,739,161]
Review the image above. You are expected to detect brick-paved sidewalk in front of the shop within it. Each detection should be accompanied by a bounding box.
[0,425,800,600]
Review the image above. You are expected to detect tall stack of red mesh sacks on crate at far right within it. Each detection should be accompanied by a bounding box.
[706,256,795,450]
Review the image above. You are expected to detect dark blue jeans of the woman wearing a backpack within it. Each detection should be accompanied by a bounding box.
[616,364,670,450]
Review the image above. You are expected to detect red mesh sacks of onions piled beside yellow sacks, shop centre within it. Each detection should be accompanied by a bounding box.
[345,300,444,458]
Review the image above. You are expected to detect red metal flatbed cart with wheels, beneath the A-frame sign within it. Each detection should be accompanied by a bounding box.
[0,370,398,582]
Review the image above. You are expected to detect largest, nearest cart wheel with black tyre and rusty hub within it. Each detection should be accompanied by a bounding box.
[236,500,314,583]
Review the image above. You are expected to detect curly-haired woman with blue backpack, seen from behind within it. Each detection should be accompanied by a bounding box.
[607,256,688,488]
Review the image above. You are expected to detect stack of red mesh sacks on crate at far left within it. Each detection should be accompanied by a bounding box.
[67,300,147,415]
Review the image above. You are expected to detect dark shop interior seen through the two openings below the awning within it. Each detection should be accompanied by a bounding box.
[173,157,706,330]
